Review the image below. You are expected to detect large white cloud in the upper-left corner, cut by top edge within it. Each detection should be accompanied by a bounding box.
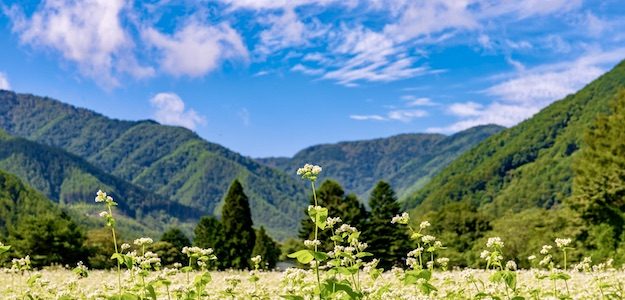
[5,0,154,87]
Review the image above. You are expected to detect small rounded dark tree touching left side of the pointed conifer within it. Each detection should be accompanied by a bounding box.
[193,216,228,269]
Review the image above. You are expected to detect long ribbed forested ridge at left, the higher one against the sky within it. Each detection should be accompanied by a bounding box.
[0,91,308,238]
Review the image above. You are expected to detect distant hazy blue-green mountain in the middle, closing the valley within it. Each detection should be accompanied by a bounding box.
[257,125,503,199]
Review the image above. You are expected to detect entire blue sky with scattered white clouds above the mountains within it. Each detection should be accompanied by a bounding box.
[0,0,625,157]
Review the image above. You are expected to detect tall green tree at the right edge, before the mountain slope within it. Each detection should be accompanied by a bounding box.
[572,90,625,259]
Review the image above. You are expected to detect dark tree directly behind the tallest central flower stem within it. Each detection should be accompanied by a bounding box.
[299,180,368,251]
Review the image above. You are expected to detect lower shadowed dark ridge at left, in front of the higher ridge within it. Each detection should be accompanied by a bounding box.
[0,129,201,236]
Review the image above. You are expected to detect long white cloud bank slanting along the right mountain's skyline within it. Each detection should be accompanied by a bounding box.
[427,48,625,133]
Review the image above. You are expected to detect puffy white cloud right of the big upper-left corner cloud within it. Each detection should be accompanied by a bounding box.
[143,21,248,77]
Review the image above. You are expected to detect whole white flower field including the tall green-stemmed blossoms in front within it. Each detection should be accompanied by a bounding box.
[0,165,625,300]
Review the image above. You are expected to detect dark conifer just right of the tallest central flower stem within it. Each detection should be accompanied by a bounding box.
[364,181,411,270]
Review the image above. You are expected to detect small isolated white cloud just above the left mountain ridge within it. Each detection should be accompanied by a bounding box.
[150,93,206,130]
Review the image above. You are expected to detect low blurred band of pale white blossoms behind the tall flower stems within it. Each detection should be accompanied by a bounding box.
[0,265,625,299]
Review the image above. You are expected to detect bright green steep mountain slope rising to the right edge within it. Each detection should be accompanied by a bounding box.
[404,62,625,264]
